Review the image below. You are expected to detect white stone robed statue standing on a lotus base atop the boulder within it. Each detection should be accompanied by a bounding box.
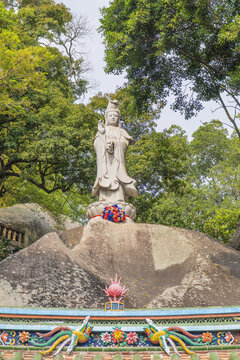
[87,100,139,218]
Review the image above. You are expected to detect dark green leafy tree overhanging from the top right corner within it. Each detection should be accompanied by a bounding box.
[100,0,240,138]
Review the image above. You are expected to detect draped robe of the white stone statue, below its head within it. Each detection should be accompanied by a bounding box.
[92,125,138,201]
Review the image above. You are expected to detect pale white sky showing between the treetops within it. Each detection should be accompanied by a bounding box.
[58,0,229,136]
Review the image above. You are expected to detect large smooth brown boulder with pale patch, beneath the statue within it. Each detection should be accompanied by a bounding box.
[72,218,240,308]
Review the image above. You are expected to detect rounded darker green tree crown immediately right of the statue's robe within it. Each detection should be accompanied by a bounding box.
[128,126,188,196]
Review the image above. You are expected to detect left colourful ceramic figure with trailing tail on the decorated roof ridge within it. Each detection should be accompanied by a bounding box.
[32,316,92,356]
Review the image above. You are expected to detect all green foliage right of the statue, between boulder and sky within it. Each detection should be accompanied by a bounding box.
[132,120,240,243]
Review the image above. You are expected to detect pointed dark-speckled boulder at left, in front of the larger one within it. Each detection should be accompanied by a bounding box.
[0,233,107,308]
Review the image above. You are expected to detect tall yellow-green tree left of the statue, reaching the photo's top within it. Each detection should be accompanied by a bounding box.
[0,0,96,196]
